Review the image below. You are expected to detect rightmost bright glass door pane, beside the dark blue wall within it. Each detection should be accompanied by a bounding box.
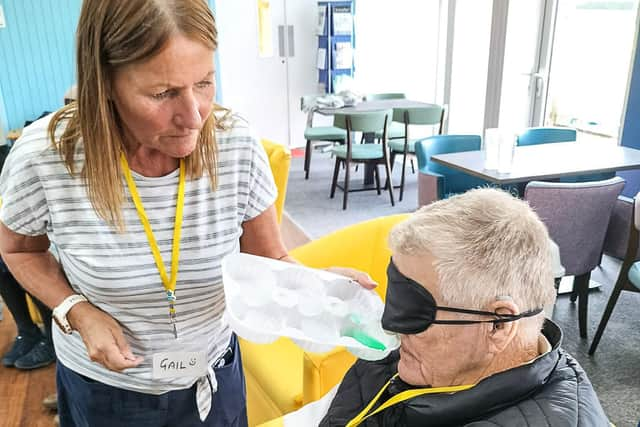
[544,0,638,143]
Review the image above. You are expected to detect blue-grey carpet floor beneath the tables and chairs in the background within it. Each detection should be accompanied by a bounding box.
[285,153,640,427]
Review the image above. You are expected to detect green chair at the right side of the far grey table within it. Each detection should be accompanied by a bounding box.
[389,105,445,201]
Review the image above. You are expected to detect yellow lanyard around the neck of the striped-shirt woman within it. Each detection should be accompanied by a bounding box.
[120,153,185,338]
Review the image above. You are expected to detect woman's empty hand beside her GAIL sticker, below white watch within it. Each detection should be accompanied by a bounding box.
[67,302,143,371]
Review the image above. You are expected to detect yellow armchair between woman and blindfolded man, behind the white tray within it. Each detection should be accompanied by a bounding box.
[240,215,407,426]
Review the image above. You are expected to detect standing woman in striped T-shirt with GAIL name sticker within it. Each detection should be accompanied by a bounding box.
[0,0,368,427]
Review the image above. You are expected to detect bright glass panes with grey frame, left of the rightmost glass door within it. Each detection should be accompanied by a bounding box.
[444,0,551,134]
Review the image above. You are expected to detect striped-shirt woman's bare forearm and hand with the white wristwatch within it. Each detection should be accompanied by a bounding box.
[0,223,142,371]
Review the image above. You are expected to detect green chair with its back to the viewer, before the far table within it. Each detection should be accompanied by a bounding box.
[330,110,395,209]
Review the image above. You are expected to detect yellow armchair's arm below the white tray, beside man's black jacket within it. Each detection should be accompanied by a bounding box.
[302,347,356,405]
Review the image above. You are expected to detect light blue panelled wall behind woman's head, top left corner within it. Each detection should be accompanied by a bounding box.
[0,0,81,129]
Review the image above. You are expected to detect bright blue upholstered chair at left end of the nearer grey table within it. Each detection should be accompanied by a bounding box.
[415,135,490,206]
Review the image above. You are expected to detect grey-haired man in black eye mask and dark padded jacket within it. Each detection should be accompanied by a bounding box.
[285,189,609,427]
